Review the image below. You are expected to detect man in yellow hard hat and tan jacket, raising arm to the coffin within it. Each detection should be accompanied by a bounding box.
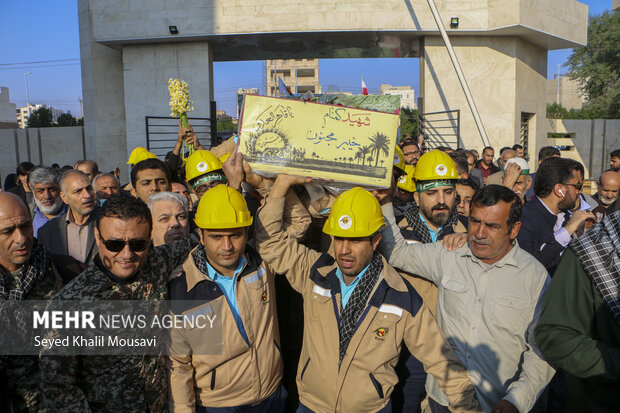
[255,175,479,413]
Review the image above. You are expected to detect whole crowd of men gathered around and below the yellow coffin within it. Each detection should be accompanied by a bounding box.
[0,122,620,413]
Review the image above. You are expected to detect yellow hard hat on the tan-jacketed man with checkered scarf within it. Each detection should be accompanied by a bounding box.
[323,186,385,238]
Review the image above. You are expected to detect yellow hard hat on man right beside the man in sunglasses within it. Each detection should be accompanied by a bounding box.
[194,184,252,229]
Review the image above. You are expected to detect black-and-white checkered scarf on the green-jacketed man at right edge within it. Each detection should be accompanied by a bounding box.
[570,211,620,324]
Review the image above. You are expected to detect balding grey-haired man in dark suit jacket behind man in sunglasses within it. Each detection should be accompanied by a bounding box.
[38,169,98,264]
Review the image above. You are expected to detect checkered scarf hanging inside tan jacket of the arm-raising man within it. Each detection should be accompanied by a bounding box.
[338,252,383,368]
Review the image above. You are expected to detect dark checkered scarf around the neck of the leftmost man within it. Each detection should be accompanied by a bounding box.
[0,246,51,332]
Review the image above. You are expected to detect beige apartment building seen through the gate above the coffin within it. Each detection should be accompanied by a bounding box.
[265,59,321,96]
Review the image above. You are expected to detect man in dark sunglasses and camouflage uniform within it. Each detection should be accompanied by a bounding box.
[40,194,198,412]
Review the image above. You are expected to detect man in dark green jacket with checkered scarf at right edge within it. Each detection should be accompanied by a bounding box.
[535,211,620,412]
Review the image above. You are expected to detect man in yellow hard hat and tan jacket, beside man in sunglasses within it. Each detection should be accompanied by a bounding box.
[169,185,287,413]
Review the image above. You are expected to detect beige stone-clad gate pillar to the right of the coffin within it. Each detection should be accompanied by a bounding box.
[420,36,547,169]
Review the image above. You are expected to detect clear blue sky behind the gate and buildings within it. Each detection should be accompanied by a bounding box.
[0,0,612,115]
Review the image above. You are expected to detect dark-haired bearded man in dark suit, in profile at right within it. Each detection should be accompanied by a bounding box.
[517,157,596,276]
